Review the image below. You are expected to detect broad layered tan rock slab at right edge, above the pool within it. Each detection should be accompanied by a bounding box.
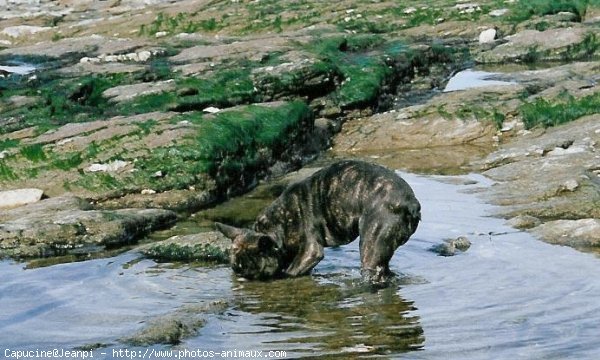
[483,114,600,219]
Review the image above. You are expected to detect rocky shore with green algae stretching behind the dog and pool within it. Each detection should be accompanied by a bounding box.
[0,0,600,261]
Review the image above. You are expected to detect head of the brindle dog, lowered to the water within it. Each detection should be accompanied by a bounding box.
[215,223,281,280]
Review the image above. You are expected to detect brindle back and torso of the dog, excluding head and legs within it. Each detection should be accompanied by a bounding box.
[255,160,420,246]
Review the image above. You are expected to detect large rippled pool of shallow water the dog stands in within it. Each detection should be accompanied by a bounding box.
[0,174,600,359]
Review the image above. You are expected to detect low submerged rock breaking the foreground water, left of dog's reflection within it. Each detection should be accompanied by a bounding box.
[121,301,229,346]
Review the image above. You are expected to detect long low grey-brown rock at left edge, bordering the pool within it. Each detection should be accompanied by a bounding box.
[0,196,177,258]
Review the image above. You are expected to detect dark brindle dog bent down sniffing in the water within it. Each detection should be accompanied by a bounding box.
[216,161,421,284]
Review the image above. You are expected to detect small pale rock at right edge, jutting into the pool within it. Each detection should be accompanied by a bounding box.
[532,219,600,247]
